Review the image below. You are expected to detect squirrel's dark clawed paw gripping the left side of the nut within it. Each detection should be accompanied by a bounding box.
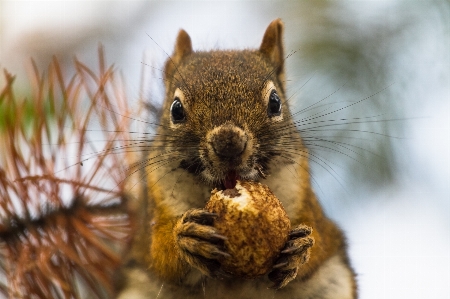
[174,209,229,277]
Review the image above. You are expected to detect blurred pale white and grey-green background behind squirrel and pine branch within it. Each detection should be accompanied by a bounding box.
[0,1,450,299]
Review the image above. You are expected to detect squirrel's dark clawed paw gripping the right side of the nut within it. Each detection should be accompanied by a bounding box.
[269,224,314,289]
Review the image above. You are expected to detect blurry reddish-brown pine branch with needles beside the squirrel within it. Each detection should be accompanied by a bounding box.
[0,49,136,298]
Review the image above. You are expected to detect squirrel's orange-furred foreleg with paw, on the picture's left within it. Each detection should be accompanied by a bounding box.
[150,209,229,280]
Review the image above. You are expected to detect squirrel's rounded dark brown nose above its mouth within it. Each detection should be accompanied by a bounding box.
[210,124,248,159]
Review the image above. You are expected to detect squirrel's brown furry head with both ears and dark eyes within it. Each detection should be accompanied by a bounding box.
[162,19,298,188]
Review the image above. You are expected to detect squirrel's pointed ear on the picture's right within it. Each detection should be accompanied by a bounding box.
[259,19,284,86]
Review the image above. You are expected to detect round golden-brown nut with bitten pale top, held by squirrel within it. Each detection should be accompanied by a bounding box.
[205,181,291,278]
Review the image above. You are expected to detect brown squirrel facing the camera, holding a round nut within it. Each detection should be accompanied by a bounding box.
[118,19,357,299]
